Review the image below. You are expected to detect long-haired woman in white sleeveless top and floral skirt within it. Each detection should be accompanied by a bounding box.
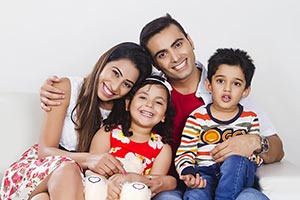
[0,42,151,200]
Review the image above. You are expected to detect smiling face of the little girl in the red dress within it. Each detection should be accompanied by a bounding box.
[126,84,168,129]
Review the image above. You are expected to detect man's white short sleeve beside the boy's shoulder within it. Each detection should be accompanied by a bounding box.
[240,96,277,136]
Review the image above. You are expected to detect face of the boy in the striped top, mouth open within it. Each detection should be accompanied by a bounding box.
[206,64,250,109]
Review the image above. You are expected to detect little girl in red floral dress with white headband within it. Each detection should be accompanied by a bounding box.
[90,76,176,199]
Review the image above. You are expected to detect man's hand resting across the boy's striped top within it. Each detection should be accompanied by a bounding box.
[211,134,261,162]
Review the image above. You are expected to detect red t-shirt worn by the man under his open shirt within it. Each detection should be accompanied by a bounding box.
[169,88,204,177]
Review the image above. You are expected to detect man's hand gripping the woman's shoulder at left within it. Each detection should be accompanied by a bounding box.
[40,75,65,112]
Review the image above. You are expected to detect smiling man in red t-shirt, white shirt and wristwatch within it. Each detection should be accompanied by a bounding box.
[41,14,284,200]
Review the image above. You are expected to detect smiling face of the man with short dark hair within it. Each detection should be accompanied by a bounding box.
[147,24,196,81]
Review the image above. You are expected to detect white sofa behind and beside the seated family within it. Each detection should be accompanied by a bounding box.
[0,92,300,200]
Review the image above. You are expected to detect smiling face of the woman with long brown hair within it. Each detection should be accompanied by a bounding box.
[98,59,139,102]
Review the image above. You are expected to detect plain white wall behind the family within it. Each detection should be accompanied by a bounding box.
[0,0,300,165]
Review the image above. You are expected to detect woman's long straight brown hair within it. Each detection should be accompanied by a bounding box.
[72,42,152,152]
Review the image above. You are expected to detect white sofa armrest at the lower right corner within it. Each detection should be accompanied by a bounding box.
[257,160,300,200]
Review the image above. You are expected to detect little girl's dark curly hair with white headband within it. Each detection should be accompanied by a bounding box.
[104,76,175,143]
